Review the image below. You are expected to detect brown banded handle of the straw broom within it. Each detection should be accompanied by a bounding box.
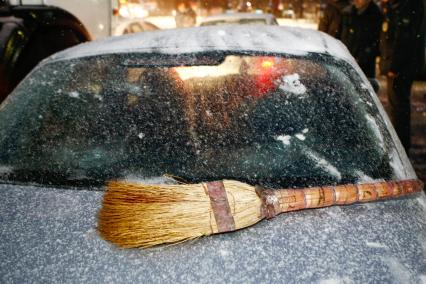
[260,180,423,218]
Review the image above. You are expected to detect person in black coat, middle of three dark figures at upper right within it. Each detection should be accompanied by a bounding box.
[341,0,382,78]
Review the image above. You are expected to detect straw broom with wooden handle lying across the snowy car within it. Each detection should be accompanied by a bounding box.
[98,180,423,248]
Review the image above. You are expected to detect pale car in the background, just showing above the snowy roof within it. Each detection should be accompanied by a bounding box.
[199,13,278,26]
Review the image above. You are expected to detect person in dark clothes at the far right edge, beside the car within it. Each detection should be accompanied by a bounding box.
[380,0,423,153]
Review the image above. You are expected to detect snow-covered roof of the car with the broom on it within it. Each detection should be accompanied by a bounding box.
[44,25,356,65]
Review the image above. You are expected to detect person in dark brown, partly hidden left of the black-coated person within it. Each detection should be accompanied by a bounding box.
[318,0,349,39]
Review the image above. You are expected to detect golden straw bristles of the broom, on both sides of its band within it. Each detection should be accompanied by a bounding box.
[98,181,262,248]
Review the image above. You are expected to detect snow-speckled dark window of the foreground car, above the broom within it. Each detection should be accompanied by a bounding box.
[0,54,410,187]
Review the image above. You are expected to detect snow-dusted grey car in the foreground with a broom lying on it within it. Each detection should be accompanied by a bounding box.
[0,25,426,283]
